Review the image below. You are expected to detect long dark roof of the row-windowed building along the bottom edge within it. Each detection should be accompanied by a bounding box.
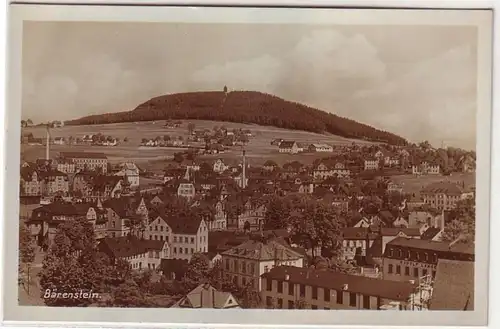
[262,266,415,301]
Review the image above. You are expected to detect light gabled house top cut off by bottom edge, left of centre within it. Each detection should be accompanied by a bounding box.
[172,283,241,309]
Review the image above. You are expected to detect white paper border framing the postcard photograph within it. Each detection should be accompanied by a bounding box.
[0,1,496,327]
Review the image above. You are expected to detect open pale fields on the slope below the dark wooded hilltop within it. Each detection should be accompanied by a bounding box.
[21,120,376,171]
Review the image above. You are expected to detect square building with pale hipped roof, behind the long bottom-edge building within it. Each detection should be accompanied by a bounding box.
[221,238,304,291]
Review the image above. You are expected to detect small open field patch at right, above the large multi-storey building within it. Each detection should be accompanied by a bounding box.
[391,173,476,193]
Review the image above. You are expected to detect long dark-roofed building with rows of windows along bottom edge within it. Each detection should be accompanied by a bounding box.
[261,266,415,310]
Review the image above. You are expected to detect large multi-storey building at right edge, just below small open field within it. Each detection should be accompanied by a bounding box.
[420,182,464,210]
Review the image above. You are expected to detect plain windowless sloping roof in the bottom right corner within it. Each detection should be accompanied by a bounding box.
[429,259,474,311]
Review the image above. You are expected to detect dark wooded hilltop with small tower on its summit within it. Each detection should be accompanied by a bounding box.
[65,91,407,145]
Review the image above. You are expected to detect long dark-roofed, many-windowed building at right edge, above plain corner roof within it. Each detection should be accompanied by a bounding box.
[383,238,474,281]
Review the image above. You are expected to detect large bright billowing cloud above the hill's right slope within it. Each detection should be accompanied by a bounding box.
[192,30,386,98]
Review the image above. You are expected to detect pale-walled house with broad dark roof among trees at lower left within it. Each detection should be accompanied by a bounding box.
[98,235,170,270]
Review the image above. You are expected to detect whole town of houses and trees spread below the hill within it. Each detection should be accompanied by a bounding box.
[19,120,475,310]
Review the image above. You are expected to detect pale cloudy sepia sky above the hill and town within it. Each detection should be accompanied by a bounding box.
[22,22,477,149]
